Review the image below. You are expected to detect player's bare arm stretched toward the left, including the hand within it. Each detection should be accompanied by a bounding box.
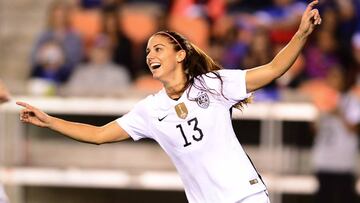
[16,102,129,144]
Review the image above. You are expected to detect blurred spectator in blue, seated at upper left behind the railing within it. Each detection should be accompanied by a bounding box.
[31,1,82,84]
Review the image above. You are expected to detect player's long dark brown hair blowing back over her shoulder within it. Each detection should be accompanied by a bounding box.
[154,31,250,109]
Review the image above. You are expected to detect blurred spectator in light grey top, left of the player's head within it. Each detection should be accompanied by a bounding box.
[62,36,130,96]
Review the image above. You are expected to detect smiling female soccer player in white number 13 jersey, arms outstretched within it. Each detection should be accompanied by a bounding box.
[17,1,321,203]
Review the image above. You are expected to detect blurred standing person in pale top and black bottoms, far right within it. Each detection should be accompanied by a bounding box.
[312,68,360,203]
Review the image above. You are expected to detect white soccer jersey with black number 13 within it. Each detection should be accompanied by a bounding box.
[117,70,266,203]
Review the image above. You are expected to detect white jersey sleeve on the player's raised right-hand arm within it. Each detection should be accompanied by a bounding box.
[219,70,251,106]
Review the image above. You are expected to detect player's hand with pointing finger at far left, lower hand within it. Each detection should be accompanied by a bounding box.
[16,101,51,127]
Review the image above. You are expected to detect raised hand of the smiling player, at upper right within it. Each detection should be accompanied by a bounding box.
[298,0,321,37]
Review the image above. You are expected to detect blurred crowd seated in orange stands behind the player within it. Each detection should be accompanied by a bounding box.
[30,0,360,107]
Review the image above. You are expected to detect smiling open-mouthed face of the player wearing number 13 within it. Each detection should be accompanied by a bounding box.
[146,35,183,82]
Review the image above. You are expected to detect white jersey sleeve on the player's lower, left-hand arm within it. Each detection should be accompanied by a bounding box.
[116,99,151,141]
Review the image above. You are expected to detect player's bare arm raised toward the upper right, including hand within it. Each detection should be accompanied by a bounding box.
[246,0,321,92]
